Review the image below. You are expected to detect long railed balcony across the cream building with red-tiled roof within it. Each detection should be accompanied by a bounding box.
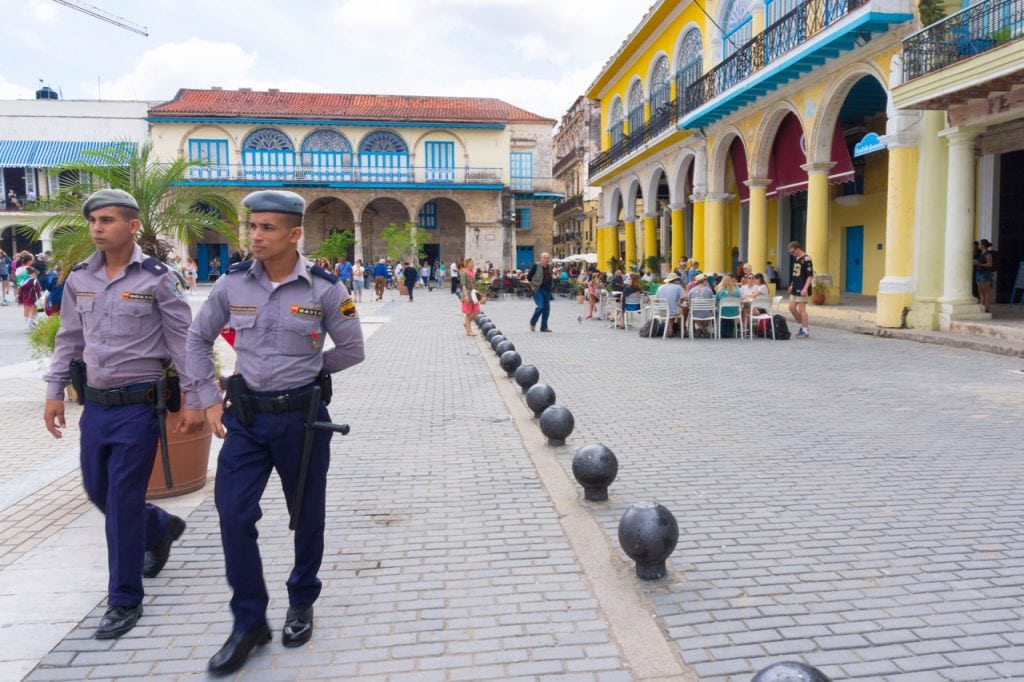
[184,164,506,189]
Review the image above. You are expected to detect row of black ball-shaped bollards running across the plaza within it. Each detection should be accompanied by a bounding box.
[475,313,830,682]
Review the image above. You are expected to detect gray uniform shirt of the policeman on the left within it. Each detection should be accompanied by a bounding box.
[43,244,199,408]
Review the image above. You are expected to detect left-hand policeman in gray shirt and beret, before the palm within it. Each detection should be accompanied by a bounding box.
[43,189,205,639]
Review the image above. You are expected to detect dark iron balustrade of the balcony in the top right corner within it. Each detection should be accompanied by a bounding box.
[903,0,1024,83]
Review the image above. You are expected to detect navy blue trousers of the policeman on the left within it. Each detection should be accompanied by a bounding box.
[79,401,171,606]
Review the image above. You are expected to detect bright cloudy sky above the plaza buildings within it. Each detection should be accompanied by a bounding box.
[0,0,653,119]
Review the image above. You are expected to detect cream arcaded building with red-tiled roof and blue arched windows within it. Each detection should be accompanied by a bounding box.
[148,88,561,279]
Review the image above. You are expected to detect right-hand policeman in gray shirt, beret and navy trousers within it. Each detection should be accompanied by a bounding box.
[187,190,364,674]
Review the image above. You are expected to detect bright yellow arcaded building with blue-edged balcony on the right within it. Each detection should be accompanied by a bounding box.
[587,0,1021,328]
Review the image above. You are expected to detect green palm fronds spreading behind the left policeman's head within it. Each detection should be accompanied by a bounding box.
[33,141,239,272]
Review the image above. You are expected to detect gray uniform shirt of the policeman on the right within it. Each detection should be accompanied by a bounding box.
[187,257,364,407]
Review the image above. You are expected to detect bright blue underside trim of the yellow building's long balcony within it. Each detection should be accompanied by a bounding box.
[676,12,913,130]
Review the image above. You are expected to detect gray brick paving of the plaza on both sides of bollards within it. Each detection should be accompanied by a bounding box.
[8,292,1024,681]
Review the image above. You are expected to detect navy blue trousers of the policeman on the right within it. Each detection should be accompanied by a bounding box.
[214,403,332,632]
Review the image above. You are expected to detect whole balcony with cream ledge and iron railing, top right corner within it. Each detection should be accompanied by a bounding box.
[893,0,1024,110]
